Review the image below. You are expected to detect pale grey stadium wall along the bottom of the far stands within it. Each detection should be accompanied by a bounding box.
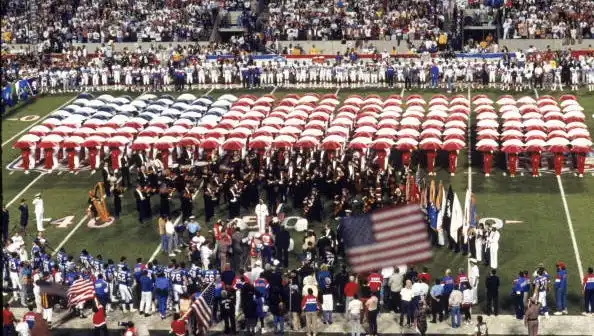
[3,39,594,54]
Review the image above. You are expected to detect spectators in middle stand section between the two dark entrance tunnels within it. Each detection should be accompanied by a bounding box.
[264,0,447,40]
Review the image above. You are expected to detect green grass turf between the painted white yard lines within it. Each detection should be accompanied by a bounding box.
[2,89,594,313]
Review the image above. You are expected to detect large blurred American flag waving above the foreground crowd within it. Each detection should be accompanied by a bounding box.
[341,204,432,273]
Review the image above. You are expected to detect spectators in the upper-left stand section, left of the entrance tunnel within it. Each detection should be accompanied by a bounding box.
[2,0,221,47]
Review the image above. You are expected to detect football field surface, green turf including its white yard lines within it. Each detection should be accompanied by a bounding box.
[2,88,594,314]
